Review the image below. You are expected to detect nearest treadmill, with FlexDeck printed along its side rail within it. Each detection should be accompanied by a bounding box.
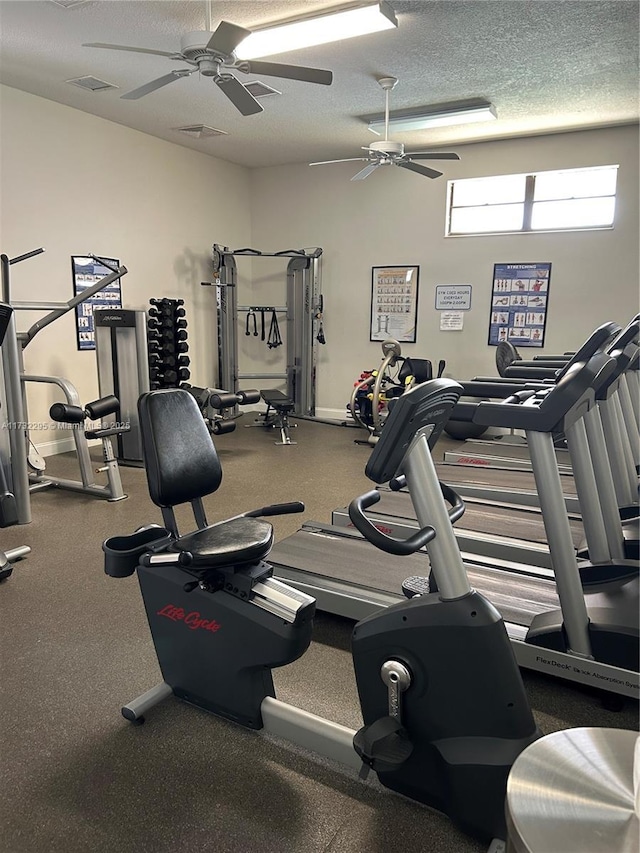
[270,338,640,699]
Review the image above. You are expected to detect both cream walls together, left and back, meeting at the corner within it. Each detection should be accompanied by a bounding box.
[0,87,639,432]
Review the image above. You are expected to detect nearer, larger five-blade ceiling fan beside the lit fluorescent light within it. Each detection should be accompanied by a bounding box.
[83,0,333,116]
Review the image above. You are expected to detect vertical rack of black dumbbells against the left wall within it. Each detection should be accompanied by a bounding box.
[147,298,191,390]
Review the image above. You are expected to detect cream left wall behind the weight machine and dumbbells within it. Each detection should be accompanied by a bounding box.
[0,87,250,453]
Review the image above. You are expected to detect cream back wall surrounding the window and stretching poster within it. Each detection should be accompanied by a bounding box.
[249,126,639,416]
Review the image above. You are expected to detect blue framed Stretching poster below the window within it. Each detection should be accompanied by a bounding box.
[488,263,551,347]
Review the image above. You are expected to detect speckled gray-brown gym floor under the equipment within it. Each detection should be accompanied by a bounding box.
[0,416,638,853]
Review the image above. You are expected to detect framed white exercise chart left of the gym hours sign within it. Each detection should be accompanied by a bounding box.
[369,266,420,343]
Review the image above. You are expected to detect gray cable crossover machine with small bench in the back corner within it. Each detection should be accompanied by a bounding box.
[203,243,325,444]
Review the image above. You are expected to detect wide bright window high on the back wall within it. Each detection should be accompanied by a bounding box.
[447,166,618,236]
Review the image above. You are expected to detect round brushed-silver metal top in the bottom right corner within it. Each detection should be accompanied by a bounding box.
[506,728,640,853]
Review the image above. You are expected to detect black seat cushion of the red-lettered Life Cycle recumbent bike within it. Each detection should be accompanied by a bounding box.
[167,517,273,569]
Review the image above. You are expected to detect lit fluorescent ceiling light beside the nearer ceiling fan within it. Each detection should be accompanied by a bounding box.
[236,2,398,59]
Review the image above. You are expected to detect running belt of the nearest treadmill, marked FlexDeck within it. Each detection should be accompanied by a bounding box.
[269,530,560,627]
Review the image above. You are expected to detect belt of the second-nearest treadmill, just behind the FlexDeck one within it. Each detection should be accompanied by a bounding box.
[364,486,584,548]
